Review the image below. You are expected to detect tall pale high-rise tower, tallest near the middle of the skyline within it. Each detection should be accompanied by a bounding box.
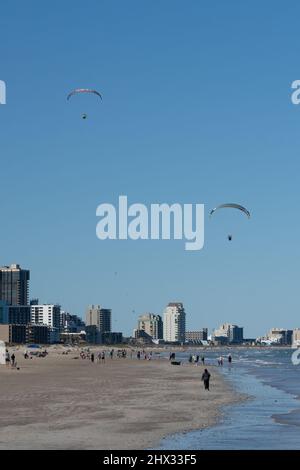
[163,302,185,342]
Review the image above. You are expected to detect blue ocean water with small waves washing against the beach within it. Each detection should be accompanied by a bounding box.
[160,348,300,450]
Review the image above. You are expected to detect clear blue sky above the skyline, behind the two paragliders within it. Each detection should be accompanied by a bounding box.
[0,0,300,337]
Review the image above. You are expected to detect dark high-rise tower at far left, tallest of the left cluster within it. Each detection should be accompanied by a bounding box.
[0,264,30,305]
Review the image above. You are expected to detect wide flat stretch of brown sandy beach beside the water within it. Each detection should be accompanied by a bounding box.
[0,349,240,449]
